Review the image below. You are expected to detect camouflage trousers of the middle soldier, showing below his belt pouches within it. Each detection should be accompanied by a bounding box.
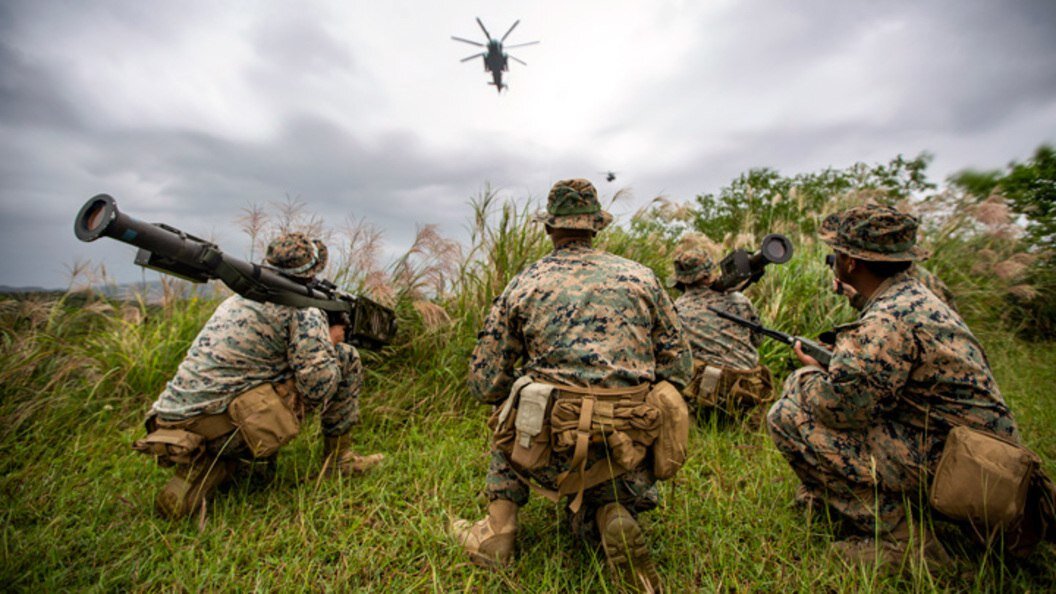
[487,446,660,540]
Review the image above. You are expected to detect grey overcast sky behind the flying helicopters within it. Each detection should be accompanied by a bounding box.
[0,0,1056,287]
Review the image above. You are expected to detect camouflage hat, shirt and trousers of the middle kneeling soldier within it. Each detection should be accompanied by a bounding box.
[469,181,692,533]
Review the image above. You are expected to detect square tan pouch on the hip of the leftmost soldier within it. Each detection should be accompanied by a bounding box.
[227,384,301,458]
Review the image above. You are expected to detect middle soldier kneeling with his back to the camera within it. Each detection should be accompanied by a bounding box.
[452,180,691,592]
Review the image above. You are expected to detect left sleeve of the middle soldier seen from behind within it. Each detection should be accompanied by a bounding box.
[469,282,525,404]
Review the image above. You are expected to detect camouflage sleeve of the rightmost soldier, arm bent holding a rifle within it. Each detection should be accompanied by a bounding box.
[799,315,917,429]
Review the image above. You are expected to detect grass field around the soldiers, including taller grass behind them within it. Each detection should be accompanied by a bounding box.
[0,188,1056,592]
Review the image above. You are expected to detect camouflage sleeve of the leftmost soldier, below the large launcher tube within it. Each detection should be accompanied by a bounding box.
[286,308,341,406]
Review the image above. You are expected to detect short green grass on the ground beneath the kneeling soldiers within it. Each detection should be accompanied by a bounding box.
[0,298,1056,592]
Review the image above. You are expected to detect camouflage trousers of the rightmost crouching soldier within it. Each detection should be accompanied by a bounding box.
[767,374,936,534]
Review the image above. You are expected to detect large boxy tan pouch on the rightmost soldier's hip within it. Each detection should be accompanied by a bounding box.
[928,426,1040,534]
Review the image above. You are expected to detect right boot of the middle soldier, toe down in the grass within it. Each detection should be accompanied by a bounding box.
[596,503,661,594]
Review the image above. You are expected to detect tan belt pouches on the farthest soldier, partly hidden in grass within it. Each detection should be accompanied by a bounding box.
[685,360,773,413]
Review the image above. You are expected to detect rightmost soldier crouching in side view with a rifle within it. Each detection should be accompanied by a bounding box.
[768,205,1056,569]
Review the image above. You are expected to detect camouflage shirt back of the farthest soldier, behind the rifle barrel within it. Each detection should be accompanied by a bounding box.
[675,285,762,369]
